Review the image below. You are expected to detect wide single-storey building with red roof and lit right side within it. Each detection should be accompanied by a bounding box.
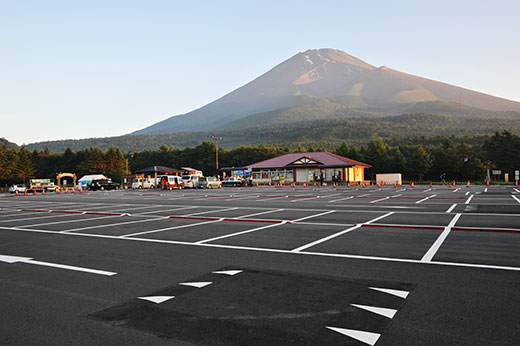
[248,151,372,183]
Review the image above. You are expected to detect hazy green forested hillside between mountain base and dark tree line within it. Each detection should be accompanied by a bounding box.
[26,113,520,152]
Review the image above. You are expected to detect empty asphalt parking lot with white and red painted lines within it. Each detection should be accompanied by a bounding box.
[0,186,520,345]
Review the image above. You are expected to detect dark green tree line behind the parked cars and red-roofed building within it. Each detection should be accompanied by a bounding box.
[0,131,520,186]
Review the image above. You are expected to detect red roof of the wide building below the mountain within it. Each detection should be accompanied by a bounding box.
[250,151,372,169]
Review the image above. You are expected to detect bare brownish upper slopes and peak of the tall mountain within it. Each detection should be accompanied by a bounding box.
[133,49,520,134]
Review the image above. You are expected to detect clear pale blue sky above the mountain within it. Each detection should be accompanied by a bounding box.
[0,0,520,144]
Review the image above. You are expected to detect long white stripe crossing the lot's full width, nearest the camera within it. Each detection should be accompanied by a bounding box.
[0,224,520,272]
